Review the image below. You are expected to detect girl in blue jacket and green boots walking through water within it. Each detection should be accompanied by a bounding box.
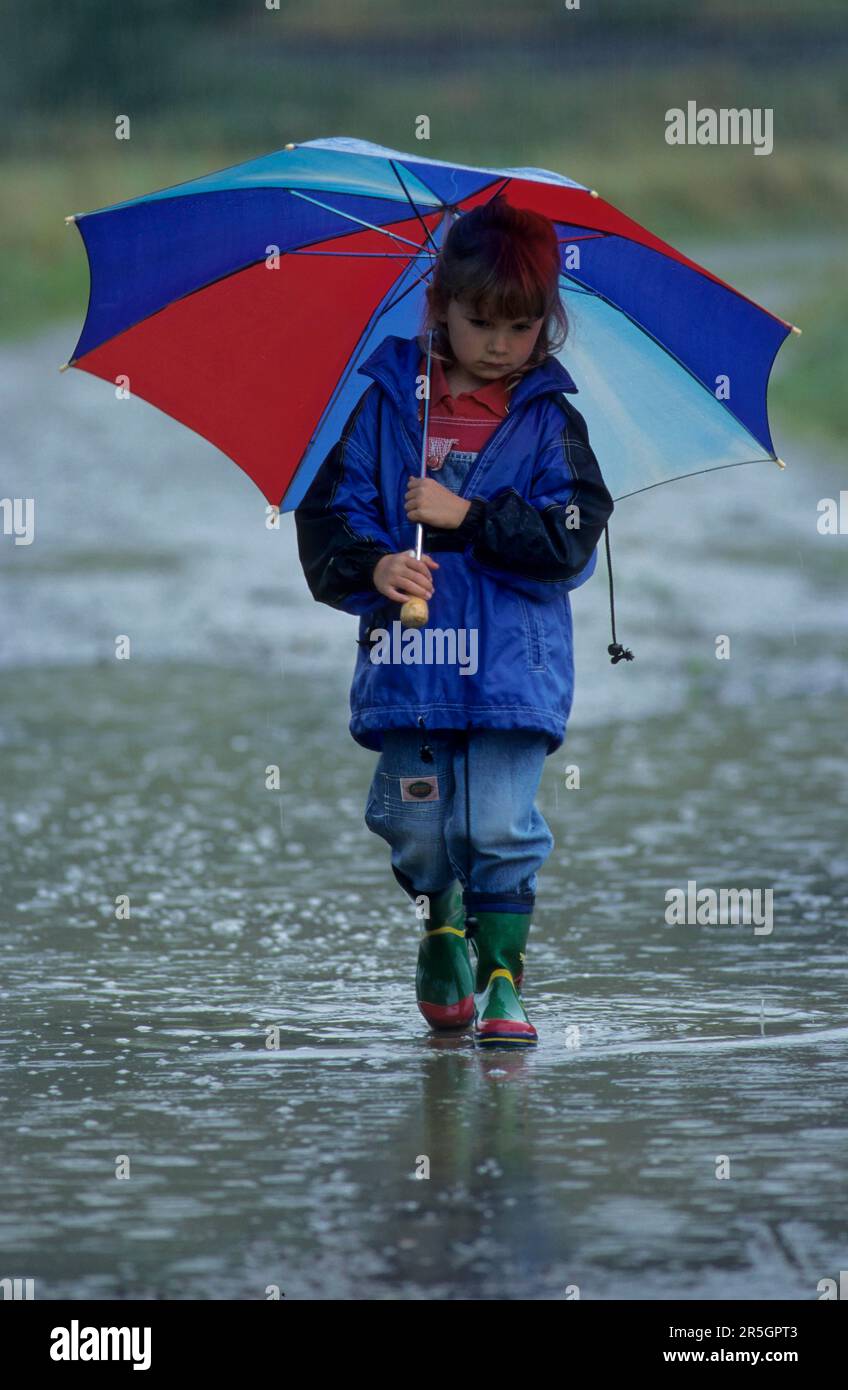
[295,196,613,1047]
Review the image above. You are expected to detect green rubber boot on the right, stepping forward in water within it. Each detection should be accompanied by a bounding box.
[471,912,538,1047]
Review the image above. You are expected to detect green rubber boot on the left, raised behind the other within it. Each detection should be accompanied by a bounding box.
[416,883,474,1029]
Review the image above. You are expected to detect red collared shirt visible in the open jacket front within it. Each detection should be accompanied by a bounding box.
[418,356,509,485]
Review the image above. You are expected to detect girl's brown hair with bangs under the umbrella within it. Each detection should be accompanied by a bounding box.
[421,195,569,386]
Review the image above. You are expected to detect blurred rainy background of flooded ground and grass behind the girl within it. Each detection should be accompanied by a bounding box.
[0,0,848,1300]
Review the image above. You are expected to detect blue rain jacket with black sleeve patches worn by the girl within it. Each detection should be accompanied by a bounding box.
[295,336,613,753]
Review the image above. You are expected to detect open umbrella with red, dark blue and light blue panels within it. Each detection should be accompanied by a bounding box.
[63,136,801,650]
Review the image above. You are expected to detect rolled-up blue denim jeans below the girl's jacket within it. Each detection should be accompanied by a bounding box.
[366,728,553,916]
